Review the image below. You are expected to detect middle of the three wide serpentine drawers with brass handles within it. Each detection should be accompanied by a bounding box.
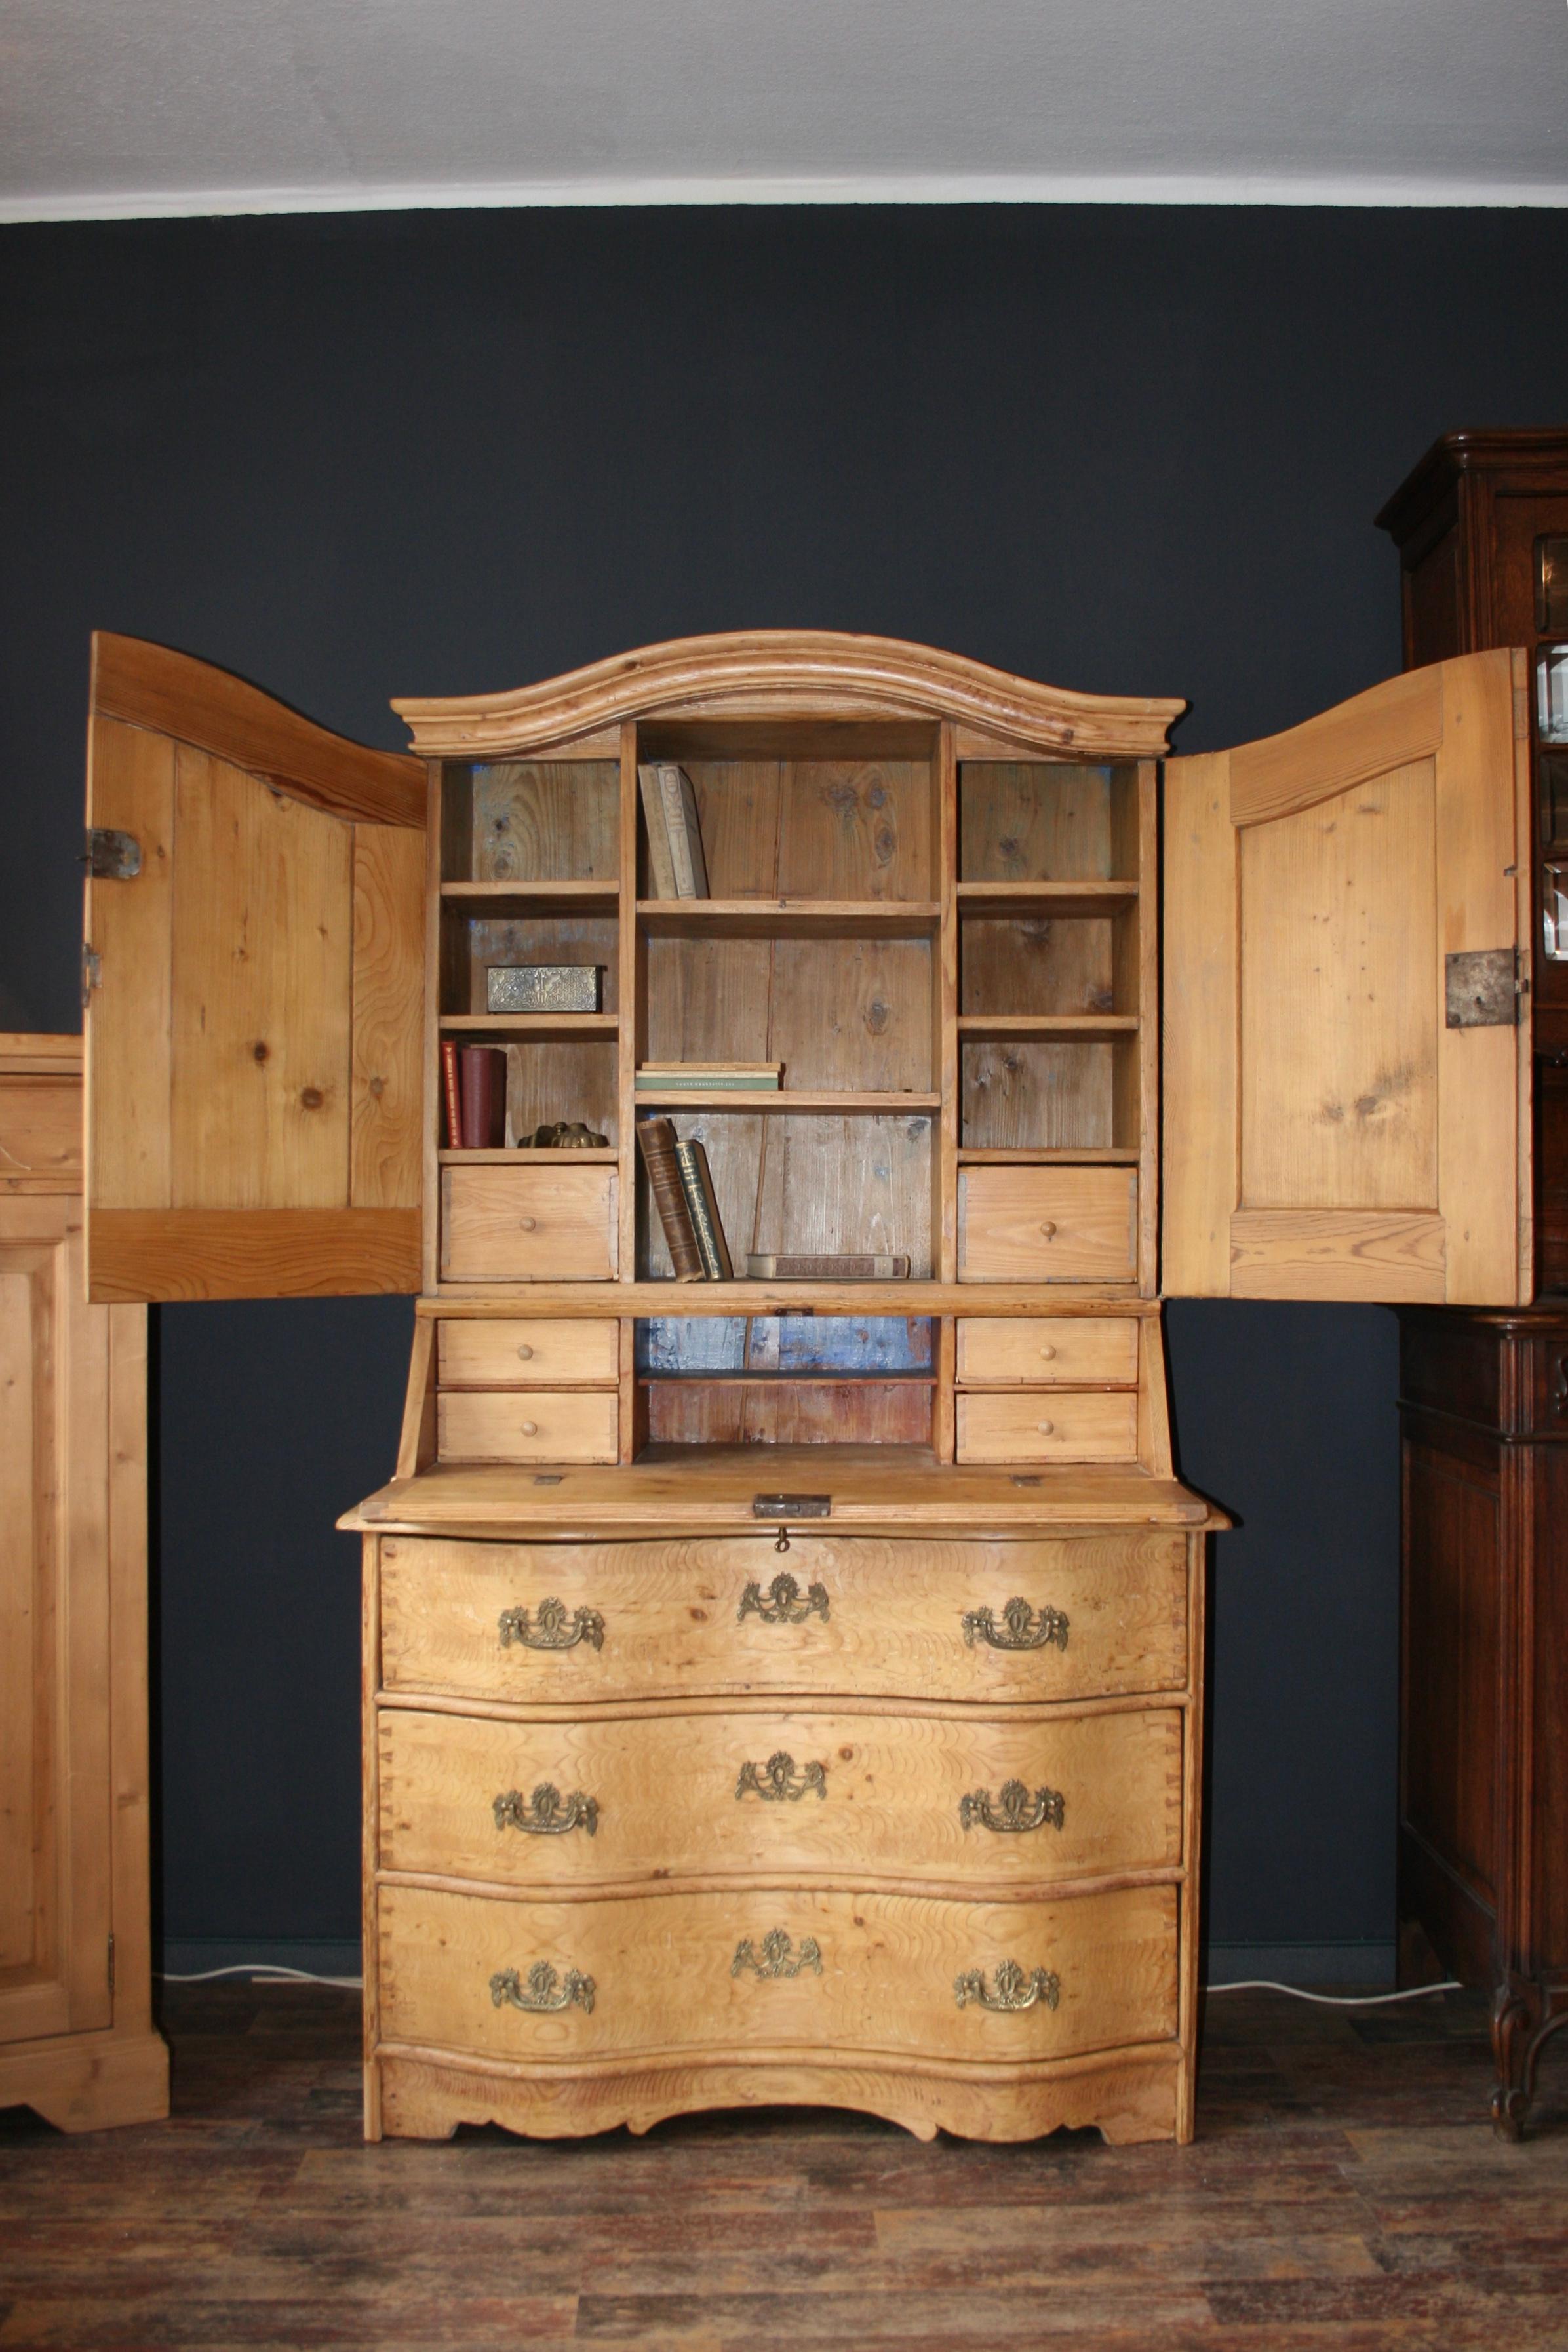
[378,1708,1183,1893]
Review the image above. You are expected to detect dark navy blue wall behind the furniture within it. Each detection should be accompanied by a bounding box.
[0,207,1568,1943]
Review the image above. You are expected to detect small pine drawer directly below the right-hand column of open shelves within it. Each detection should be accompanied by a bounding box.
[959,1167,1138,1282]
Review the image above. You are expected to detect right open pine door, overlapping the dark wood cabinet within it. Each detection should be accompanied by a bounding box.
[1164,652,1533,1305]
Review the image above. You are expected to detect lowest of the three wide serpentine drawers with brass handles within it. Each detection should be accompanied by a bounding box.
[378,1884,1178,2068]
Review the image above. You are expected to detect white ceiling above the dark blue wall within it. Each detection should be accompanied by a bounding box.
[0,0,1568,221]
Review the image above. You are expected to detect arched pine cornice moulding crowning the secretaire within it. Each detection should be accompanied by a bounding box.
[393,628,1187,760]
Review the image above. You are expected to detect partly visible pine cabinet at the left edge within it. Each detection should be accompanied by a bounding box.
[0,1035,169,2131]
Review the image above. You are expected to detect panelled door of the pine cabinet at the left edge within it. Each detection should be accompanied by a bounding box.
[0,1195,111,2041]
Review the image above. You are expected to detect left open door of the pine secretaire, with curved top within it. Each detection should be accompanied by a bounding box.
[83,635,425,1301]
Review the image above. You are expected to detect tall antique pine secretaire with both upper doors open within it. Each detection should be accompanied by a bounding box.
[76,633,1533,2140]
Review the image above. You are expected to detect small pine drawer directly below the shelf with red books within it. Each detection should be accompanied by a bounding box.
[442,1167,616,1282]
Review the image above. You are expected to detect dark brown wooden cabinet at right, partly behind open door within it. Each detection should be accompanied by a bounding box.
[1378,431,1568,2133]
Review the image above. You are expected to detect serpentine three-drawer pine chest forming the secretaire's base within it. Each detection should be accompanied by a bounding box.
[366,1533,1196,2138]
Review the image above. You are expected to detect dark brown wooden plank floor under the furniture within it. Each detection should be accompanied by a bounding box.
[0,1985,1568,2352]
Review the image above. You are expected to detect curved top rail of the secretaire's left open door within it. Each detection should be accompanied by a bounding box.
[92,631,425,825]
